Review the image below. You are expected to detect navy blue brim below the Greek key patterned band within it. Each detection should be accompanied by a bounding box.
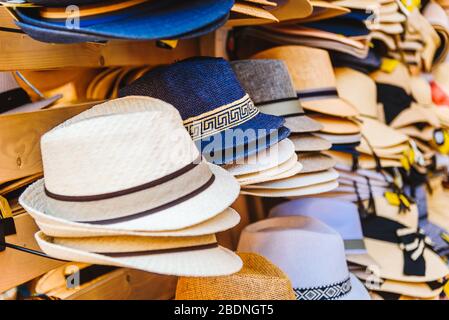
[200,112,290,164]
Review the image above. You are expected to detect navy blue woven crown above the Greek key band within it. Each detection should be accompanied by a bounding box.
[119,57,246,120]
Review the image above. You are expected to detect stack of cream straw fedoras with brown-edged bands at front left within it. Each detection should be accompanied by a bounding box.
[19,97,242,276]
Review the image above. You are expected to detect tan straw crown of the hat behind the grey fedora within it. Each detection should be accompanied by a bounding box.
[254,46,336,91]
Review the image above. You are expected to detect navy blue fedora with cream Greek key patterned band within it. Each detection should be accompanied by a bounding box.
[119,57,289,164]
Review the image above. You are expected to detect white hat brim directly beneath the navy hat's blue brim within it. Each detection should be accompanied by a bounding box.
[222,138,295,176]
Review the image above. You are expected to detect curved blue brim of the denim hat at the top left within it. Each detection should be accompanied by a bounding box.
[16,0,234,40]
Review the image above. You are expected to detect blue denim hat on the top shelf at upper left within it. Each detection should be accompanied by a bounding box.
[14,0,234,40]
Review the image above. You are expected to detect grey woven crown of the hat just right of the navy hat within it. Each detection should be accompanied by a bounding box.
[231,59,296,105]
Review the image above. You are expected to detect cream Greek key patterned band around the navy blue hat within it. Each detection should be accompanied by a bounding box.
[184,94,259,141]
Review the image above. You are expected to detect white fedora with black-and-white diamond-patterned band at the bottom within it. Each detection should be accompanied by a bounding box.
[238,217,370,300]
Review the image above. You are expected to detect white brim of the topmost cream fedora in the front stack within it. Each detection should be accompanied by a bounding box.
[19,164,240,231]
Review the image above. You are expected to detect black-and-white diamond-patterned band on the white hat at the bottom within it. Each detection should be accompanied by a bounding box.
[293,276,352,300]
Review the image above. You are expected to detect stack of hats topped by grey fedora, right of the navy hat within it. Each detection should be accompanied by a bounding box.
[225,59,337,197]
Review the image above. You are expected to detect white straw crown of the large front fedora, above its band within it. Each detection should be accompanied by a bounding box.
[41,97,199,196]
